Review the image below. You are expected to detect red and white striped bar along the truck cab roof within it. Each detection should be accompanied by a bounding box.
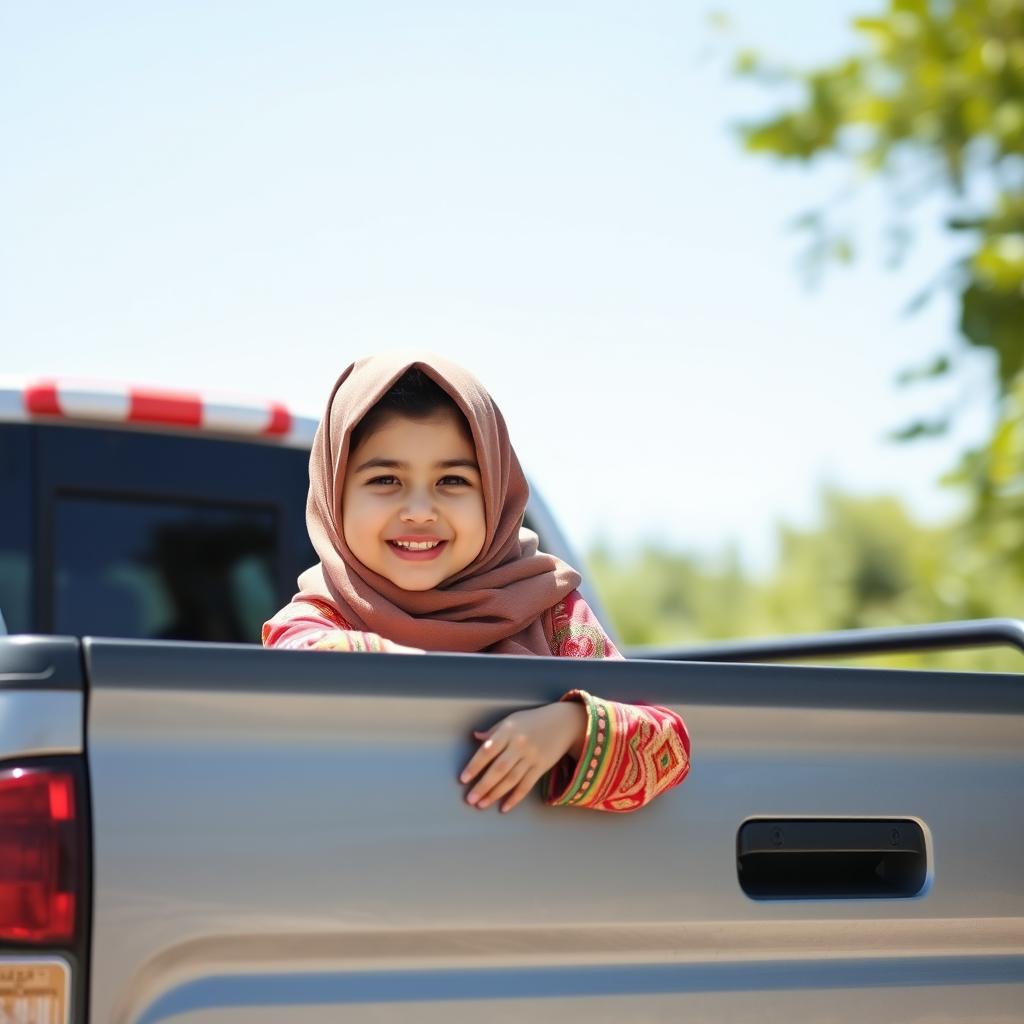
[0,379,316,447]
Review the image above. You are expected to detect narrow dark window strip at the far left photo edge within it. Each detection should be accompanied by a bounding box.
[0,424,32,633]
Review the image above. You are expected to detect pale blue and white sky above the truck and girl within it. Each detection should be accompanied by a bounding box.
[0,0,984,562]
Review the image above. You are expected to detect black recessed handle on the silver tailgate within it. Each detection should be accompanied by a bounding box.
[736,818,928,899]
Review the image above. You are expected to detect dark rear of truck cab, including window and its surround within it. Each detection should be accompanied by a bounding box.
[24,425,315,643]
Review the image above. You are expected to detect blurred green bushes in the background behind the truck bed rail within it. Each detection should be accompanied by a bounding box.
[588,487,1024,672]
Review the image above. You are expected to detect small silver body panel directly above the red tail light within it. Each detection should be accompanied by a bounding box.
[0,690,83,758]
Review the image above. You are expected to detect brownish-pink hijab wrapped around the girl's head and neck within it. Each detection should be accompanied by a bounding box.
[296,354,580,654]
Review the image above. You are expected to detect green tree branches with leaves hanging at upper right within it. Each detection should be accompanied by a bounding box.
[717,0,1024,580]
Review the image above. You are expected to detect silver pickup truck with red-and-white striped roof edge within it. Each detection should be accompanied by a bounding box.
[0,382,1024,1024]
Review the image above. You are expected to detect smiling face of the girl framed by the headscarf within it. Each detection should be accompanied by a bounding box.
[341,412,485,590]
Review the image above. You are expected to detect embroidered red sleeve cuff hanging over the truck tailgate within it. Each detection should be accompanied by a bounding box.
[546,690,690,812]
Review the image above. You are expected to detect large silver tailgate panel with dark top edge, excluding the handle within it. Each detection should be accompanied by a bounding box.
[89,644,1024,1024]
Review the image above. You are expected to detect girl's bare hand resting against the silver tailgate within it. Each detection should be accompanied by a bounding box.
[459,700,587,813]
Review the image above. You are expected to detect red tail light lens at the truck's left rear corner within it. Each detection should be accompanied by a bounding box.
[0,768,79,943]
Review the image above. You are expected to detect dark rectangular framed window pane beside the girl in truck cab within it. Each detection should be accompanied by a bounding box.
[54,495,279,643]
